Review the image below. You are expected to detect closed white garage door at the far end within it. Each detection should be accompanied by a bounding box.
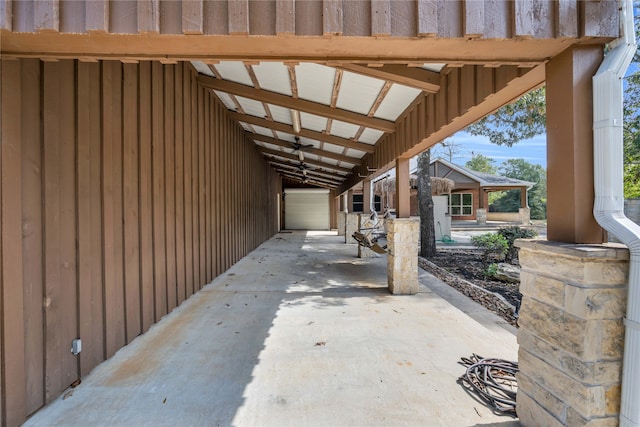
[284,188,329,230]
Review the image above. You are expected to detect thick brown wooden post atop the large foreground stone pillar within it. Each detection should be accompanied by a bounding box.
[546,46,605,243]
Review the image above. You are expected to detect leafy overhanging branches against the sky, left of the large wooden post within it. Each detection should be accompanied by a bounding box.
[465,87,547,147]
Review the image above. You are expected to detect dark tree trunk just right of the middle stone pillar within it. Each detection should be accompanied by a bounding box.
[418,150,436,258]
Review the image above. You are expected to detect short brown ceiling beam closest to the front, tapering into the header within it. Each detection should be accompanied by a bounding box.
[336,64,440,93]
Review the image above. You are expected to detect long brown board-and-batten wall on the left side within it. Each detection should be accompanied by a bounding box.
[0,59,280,425]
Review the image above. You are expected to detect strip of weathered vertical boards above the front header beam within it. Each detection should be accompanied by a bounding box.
[0,0,618,39]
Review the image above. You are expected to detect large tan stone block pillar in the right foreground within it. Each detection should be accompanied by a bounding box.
[516,240,629,427]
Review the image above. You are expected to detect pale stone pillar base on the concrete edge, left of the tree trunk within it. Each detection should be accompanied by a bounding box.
[387,218,420,295]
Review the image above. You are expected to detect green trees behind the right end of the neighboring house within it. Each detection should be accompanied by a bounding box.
[489,159,547,219]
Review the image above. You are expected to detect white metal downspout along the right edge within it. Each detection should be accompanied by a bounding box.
[593,0,640,427]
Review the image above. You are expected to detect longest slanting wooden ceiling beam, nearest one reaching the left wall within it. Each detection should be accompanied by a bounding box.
[198,74,396,133]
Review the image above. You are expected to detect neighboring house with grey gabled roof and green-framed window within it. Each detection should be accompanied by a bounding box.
[429,158,534,224]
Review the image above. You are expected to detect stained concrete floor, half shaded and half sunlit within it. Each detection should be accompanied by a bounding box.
[25,232,519,427]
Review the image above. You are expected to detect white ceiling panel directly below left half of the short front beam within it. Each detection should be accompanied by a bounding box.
[336,71,384,114]
